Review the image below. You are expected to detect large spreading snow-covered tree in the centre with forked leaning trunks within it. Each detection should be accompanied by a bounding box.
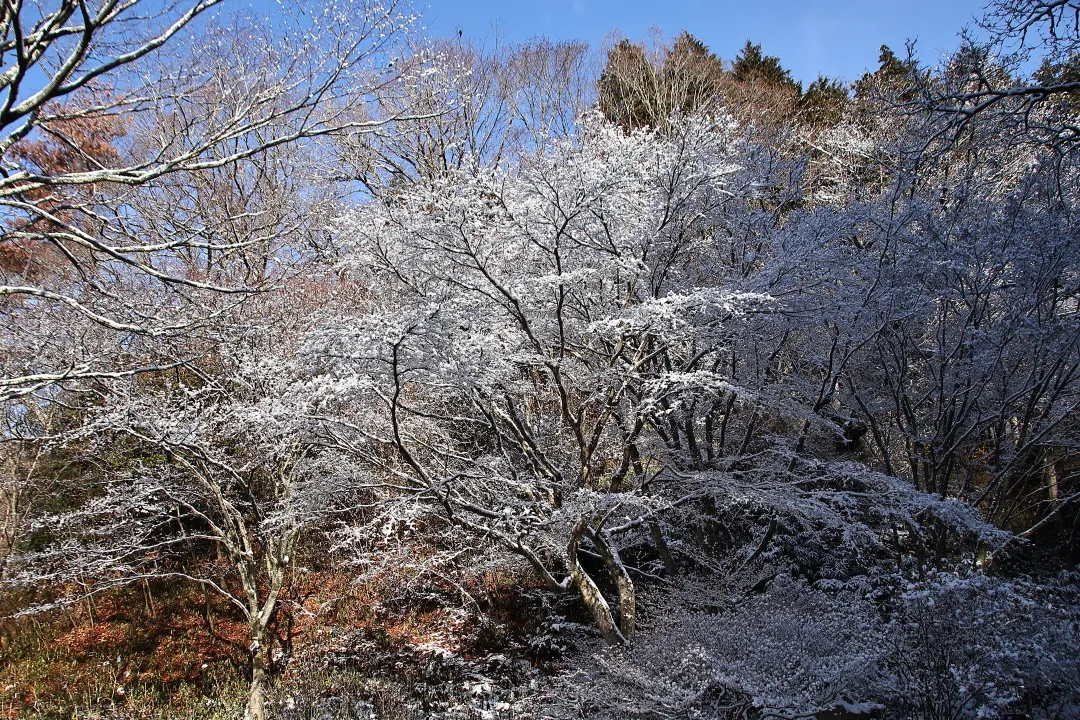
[307,112,1002,642]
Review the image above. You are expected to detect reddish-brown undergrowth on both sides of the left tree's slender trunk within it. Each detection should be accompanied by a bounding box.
[0,569,557,719]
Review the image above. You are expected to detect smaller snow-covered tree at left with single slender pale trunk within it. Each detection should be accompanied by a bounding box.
[8,285,374,720]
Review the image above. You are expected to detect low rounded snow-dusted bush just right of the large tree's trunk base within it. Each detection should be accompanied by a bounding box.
[548,575,889,718]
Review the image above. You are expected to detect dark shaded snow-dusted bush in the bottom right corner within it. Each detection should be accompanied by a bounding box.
[893,572,1080,719]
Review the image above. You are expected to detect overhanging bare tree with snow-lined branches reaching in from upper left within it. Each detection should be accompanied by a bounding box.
[0,0,413,400]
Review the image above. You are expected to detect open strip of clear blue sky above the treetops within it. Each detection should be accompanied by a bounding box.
[417,0,984,84]
